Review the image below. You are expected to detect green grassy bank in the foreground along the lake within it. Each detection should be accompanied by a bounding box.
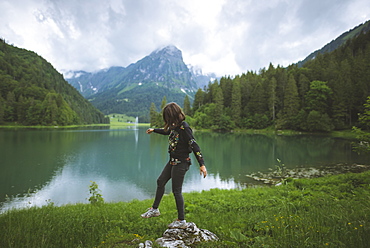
[0,172,370,247]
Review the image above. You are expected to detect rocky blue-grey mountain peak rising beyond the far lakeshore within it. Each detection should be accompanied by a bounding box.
[66,46,215,121]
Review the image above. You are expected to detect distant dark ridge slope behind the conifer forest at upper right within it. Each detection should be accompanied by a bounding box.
[297,20,370,67]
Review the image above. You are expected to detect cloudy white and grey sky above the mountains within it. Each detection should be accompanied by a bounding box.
[0,0,370,76]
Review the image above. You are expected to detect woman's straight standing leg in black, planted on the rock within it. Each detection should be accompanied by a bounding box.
[171,162,190,220]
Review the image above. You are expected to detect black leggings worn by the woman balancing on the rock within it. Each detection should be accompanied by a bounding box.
[153,161,190,220]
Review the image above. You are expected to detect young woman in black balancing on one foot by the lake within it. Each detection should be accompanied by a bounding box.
[141,103,207,228]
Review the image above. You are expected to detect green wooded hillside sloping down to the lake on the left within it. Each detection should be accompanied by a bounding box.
[0,40,109,125]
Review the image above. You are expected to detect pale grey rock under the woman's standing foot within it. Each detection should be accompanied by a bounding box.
[155,222,218,248]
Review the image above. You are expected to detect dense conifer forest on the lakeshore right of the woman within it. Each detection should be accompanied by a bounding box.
[150,29,370,132]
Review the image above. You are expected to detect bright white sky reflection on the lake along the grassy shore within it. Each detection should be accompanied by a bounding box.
[1,163,242,211]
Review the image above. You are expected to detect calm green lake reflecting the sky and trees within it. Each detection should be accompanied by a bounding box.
[0,127,369,211]
